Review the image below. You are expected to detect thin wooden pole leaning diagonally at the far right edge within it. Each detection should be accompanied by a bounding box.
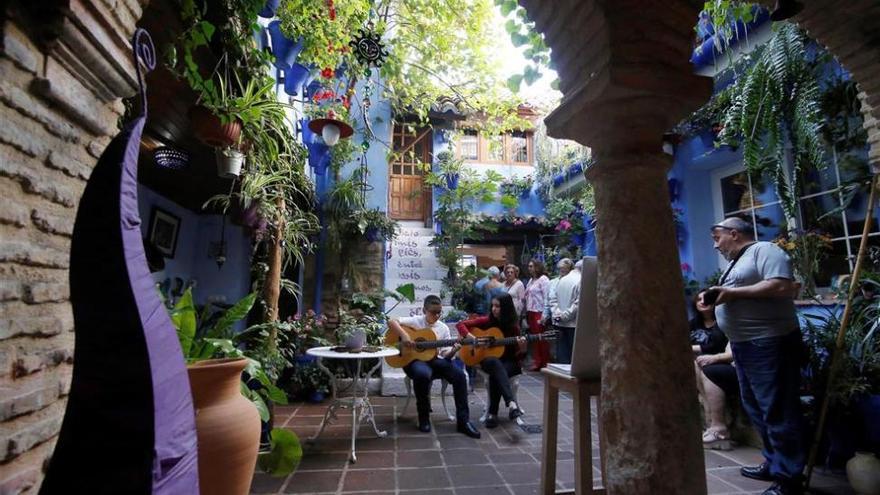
[806,176,878,488]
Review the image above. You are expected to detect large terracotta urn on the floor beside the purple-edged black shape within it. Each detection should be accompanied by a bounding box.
[187,358,260,495]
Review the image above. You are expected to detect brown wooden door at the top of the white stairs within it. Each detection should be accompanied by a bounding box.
[388,124,431,220]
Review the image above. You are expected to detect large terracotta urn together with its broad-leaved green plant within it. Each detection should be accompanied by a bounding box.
[171,289,301,480]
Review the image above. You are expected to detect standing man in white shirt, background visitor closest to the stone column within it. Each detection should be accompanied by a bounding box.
[550,258,581,364]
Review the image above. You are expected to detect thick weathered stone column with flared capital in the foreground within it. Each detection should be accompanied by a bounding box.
[519,0,711,495]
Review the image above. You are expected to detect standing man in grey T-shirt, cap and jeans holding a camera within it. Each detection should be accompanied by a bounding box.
[703,217,805,495]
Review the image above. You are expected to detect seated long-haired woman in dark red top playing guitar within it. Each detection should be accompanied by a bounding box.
[456,294,526,428]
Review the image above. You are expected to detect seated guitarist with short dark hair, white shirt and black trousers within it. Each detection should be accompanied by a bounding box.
[388,295,480,438]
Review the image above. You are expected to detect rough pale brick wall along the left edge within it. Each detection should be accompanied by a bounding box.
[0,0,146,494]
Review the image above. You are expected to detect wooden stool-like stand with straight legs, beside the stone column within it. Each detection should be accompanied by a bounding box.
[540,368,605,495]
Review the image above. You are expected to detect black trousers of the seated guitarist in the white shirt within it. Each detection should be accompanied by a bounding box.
[403,358,471,422]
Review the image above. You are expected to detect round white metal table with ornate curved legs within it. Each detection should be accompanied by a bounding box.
[306,346,400,462]
